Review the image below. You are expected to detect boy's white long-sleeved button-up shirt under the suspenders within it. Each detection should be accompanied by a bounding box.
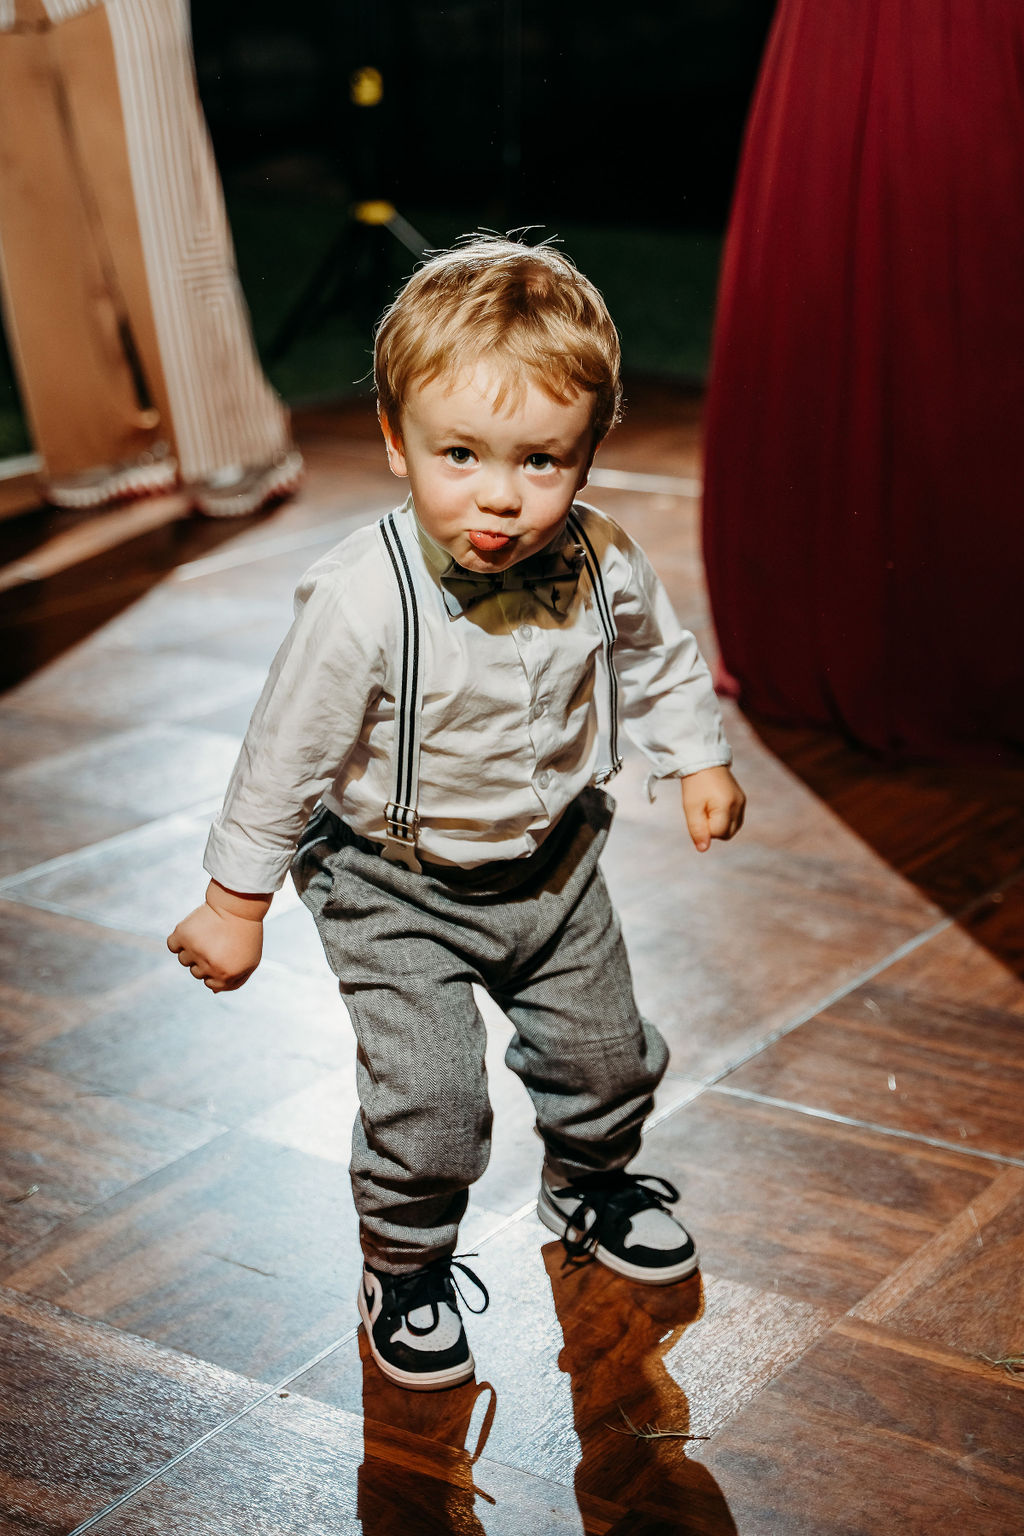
[206,502,732,894]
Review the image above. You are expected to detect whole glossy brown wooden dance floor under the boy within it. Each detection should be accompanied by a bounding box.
[0,377,1024,1536]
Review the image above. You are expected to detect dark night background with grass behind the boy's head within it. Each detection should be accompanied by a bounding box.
[0,0,774,453]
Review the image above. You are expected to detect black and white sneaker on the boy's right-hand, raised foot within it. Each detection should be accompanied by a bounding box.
[537,1169,697,1286]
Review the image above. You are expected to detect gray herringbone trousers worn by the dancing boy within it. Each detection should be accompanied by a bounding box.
[292,790,668,1273]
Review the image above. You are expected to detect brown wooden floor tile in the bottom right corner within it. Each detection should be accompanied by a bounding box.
[694,1321,1024,1536]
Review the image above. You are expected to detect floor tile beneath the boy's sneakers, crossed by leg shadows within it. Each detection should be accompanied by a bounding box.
[287,1217,831,1507]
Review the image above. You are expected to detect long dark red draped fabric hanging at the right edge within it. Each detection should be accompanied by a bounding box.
[705,0,1024,762]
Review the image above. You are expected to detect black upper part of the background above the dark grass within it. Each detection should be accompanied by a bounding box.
[193,0,772,229]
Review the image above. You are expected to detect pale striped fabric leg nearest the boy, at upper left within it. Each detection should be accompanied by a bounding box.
[100,0,289,479]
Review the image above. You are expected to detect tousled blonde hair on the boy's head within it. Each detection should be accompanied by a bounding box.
[373,235,622,444]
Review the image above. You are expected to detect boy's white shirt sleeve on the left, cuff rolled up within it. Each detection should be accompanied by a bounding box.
[204,564,384,894]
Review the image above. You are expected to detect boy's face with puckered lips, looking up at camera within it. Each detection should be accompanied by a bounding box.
[381,364,596,571]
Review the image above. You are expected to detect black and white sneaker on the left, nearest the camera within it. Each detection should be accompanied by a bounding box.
[359,1258,490,1392]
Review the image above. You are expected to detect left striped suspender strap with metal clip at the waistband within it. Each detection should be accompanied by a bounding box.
[378,511,424,871]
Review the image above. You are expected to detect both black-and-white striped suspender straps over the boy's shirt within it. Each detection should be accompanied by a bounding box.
[378,511,622,872]
